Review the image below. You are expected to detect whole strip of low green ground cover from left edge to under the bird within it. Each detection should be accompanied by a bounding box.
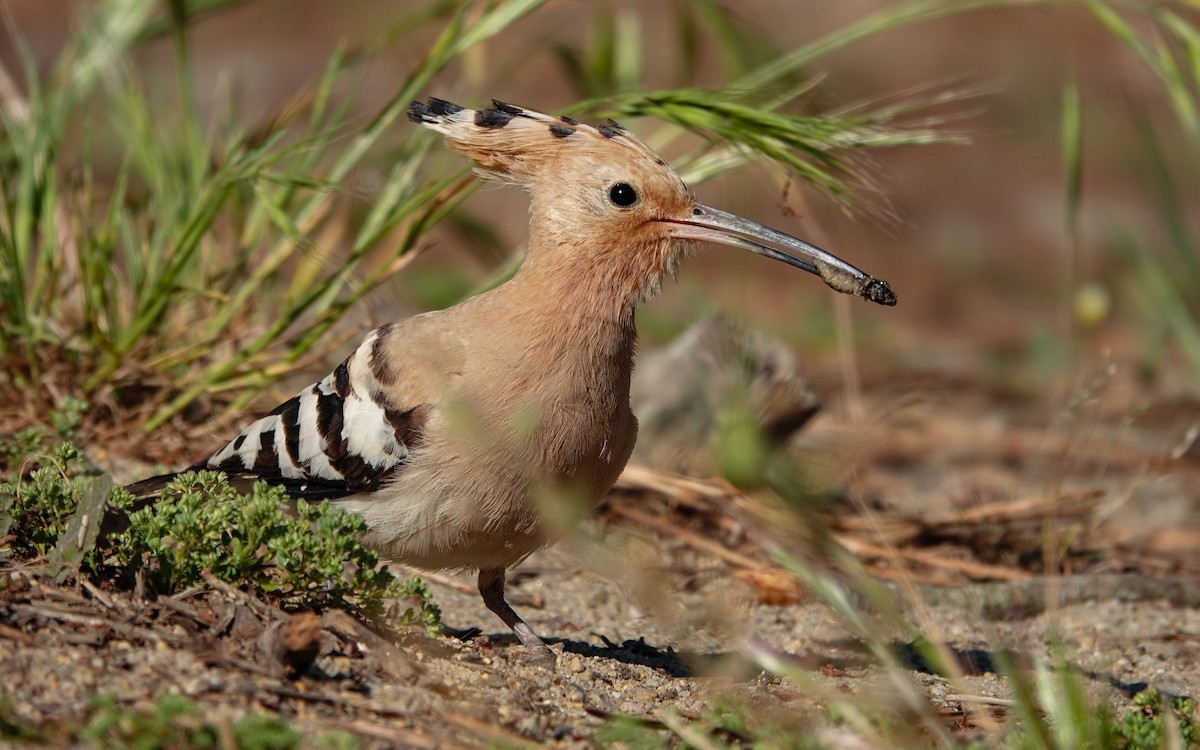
[0,432,439,631]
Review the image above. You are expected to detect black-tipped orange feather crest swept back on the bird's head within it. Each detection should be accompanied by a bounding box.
[408,97,667,182]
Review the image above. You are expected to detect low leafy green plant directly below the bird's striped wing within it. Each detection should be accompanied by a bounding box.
[109,472,439,630]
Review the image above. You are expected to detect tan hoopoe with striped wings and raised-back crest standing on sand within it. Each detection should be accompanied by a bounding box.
[128,97,896,658]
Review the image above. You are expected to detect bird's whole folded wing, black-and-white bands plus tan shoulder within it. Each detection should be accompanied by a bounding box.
[193,316,462,499]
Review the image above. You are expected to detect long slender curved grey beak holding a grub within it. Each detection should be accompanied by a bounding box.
[662,203,896,305]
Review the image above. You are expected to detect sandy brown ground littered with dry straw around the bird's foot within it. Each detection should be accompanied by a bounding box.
[0,362,1200,748]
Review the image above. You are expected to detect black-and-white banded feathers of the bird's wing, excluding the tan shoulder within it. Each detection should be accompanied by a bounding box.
[201,326,430,498]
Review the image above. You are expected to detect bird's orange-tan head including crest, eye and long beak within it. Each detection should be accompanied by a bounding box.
[408,98,896,305]
